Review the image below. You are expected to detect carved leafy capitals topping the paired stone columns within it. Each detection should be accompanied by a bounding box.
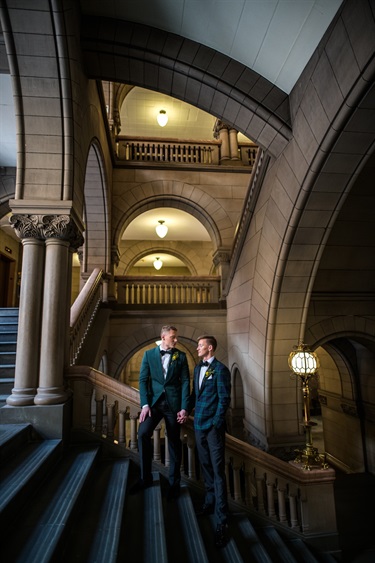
[9,214,83,250]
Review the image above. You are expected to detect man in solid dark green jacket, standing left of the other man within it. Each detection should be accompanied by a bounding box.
[131,325,190,499]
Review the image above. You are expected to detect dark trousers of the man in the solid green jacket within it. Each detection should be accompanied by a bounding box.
[138,399,182,487]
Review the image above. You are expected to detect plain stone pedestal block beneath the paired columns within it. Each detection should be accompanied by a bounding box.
[0,399,73,441]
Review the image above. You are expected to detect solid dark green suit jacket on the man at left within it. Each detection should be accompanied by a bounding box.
[139,347,190,413]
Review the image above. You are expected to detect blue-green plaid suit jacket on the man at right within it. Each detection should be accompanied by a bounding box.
[190,358,231,430]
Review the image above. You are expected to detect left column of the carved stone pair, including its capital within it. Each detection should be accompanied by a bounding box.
[7,215,44,406]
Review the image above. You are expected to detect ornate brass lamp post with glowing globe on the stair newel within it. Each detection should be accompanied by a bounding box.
[288,342,328,471]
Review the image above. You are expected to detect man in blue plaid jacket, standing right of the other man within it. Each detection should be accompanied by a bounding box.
[190,335,231,547]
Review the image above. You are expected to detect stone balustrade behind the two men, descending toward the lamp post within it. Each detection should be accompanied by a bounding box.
[66,366,337,545]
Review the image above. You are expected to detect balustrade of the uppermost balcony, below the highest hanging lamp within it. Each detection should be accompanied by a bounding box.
[116,136,258,167]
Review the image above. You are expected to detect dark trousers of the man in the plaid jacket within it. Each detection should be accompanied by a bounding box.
[195,426,228,525]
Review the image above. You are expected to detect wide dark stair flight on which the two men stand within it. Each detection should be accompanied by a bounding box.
[0,424,336,563]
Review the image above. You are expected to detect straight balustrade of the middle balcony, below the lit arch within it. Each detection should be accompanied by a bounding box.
[115,276,220,305]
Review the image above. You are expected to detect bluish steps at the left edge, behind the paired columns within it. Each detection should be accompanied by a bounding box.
[0,308,18,406]
